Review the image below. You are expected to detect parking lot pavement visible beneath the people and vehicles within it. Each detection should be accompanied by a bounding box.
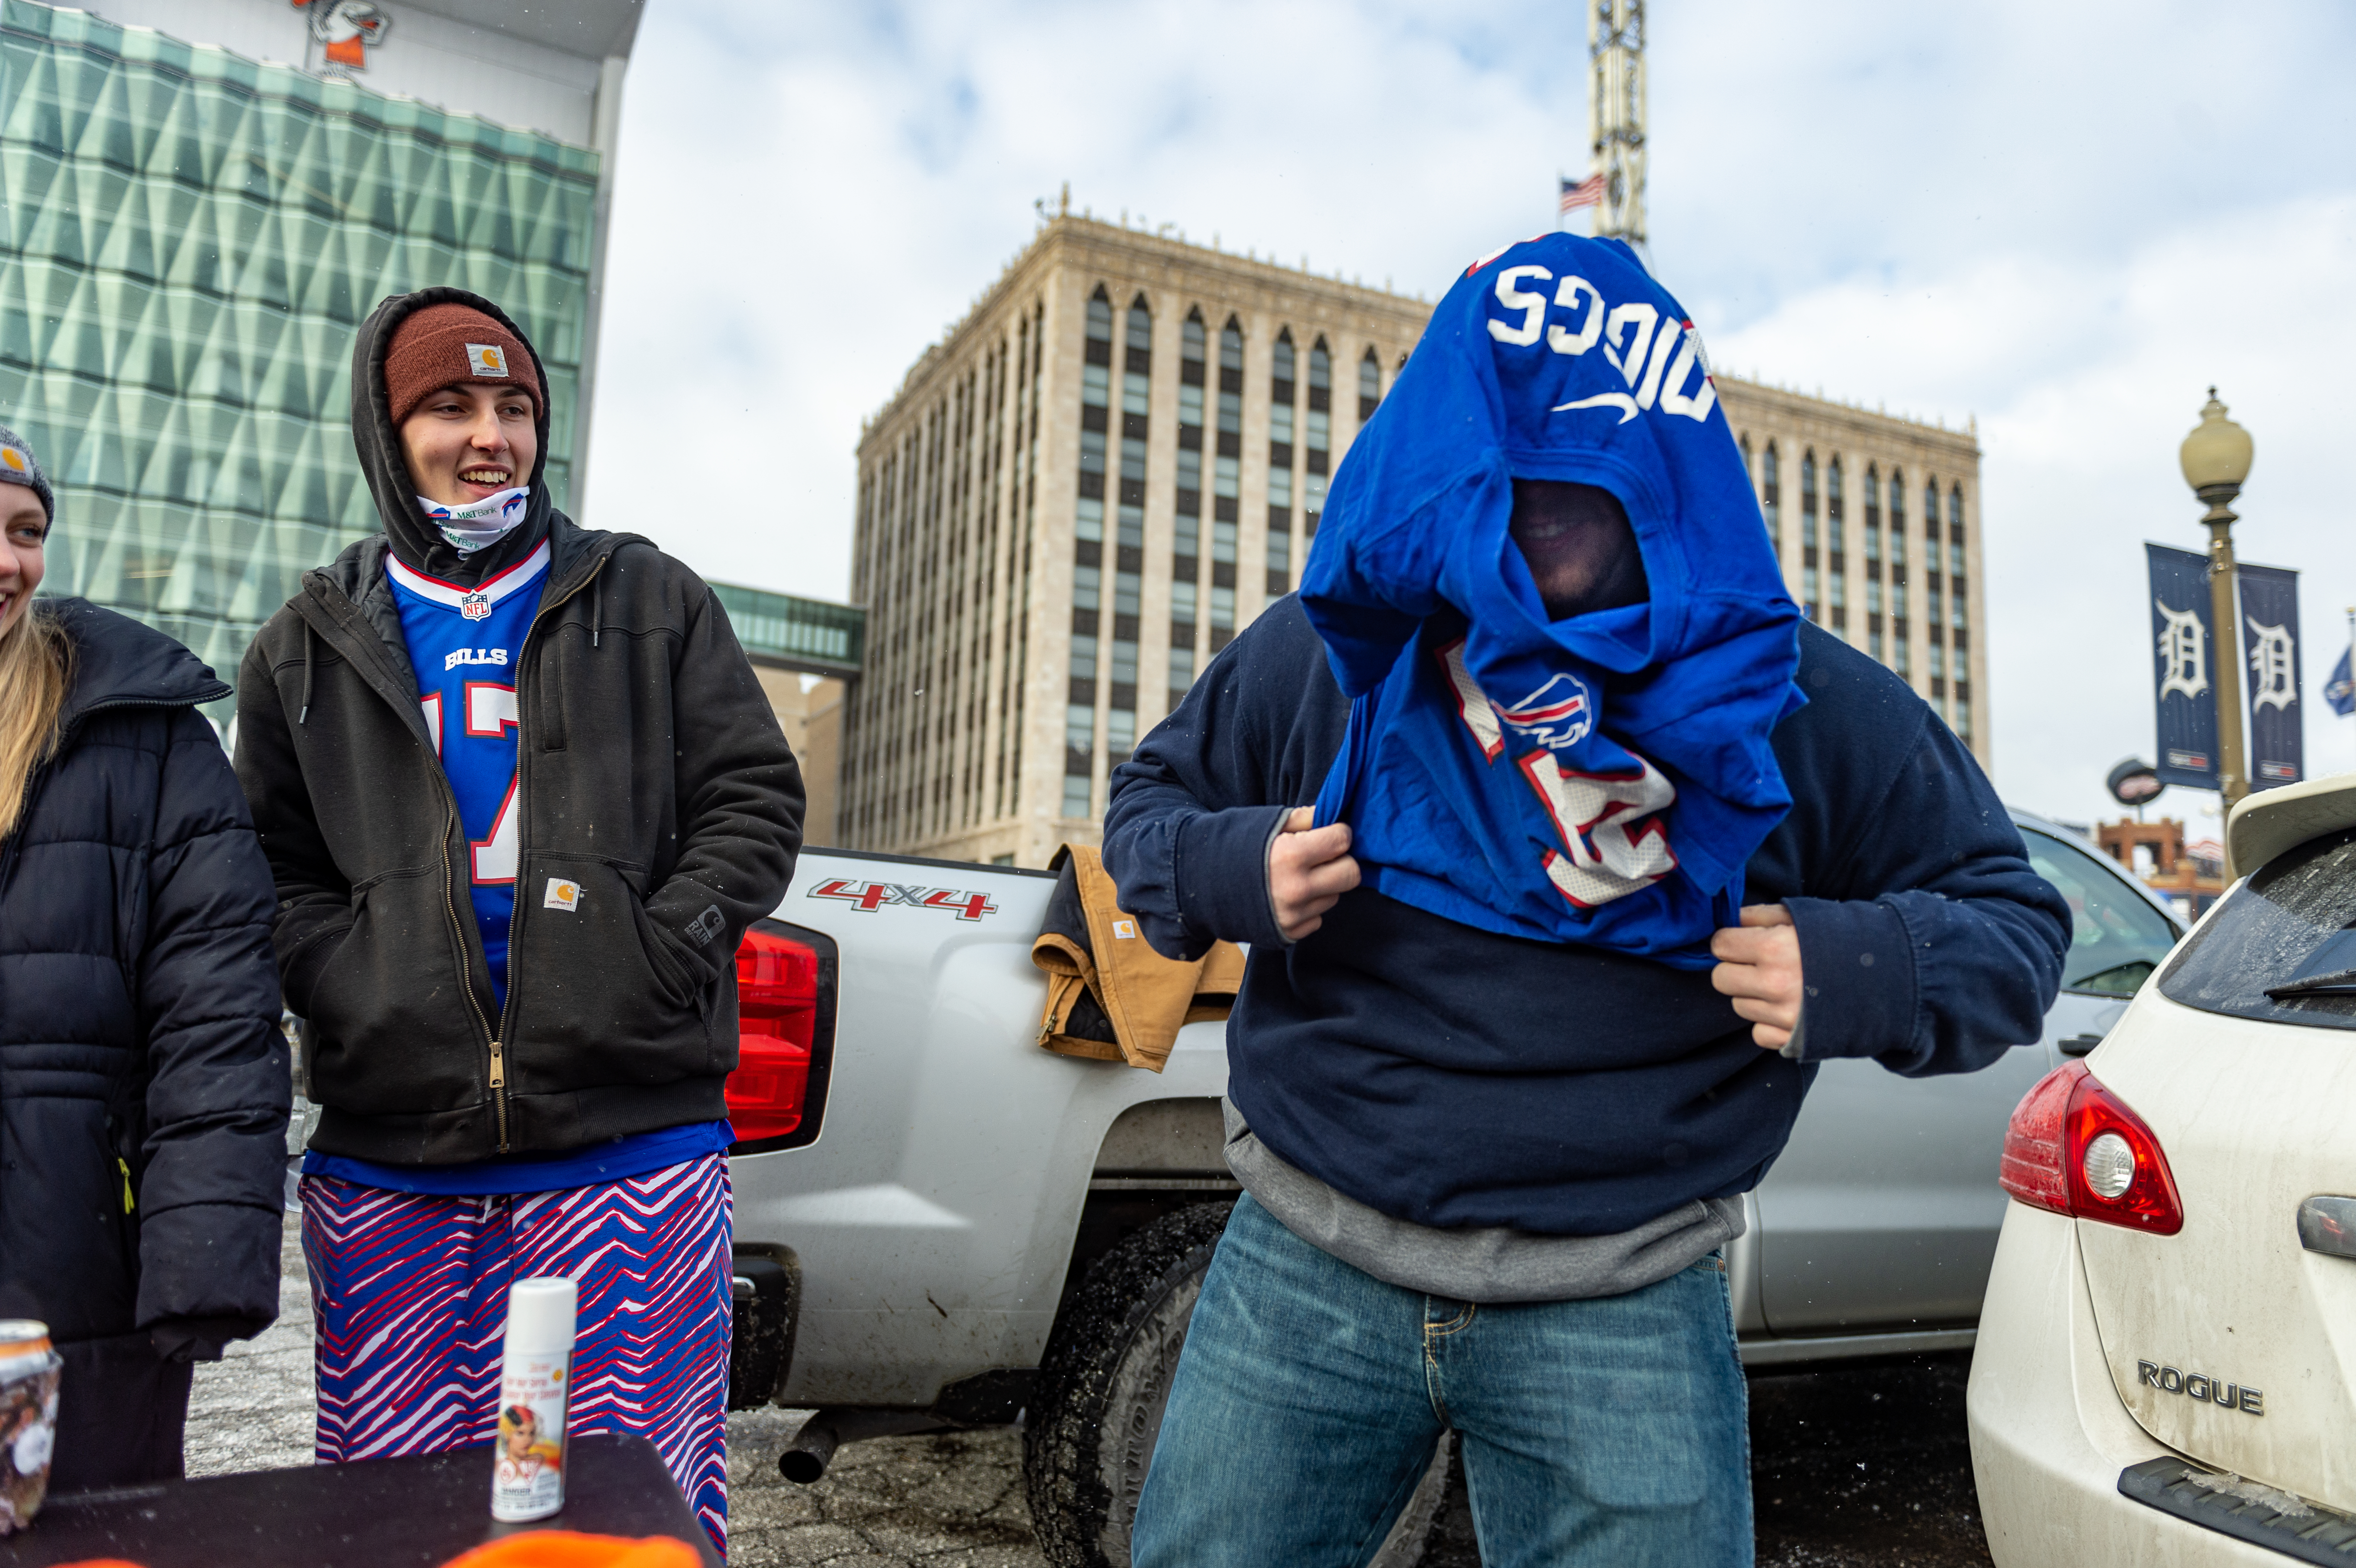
[188,1215,1988,1568]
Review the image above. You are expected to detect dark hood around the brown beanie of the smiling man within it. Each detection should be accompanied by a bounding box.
[351,287,556,586]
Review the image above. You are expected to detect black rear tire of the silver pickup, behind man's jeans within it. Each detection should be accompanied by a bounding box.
[1023,1203,1454,1568]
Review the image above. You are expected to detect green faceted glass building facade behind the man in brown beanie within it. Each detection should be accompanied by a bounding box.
[0,0,599,718]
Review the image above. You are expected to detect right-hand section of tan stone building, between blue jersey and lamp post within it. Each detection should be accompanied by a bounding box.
[1718,374,1993,768]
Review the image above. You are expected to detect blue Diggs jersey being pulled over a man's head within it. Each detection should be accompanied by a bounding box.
[1300,233,1805,968]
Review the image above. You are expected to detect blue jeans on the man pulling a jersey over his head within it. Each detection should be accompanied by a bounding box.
[1131,1194,1751,1568]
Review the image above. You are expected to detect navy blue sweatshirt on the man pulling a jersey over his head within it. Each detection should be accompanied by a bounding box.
[1105,598,2069,1236]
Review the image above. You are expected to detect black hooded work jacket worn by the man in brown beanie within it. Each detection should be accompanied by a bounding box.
[238,287,803,1165]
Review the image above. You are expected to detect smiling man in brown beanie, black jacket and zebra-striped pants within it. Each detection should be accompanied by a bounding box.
[238,287,803,1545]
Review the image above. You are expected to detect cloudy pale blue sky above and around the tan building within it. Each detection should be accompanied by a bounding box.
[584,0,2356,822]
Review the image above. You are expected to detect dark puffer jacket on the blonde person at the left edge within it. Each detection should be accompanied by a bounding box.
[0,600,292,1344]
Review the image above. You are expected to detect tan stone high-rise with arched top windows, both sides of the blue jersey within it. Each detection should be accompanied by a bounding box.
[834,217,1986,866]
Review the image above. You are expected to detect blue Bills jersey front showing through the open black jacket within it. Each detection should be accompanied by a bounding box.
[384,542,549,1022]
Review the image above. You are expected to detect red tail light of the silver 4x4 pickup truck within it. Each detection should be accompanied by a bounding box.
[728,921,834,1151]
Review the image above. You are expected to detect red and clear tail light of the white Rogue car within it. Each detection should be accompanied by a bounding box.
[1996,1062,2184,1236]
